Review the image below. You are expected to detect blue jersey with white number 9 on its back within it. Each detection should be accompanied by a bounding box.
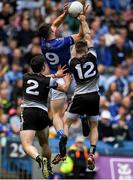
[41,36,74,73]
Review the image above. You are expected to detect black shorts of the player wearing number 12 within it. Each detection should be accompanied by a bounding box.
[67,92,100,116]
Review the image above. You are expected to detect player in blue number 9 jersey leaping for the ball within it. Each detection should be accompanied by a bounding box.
[39,5,83,142]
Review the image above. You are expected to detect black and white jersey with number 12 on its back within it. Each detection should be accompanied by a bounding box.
[69,48,99,94]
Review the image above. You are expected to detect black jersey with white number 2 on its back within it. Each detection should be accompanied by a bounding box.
[23,73,58,105]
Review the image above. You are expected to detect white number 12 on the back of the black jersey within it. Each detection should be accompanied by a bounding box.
[75,62,96,79]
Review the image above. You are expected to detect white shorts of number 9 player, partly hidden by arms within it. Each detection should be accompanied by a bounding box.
[50,78,76,100]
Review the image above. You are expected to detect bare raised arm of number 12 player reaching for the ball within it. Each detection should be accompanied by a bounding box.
[79,15,93,48]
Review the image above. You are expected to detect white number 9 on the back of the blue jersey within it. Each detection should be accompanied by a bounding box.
[45,53,59,65]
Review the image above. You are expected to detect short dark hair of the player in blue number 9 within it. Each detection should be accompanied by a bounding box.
[38,23,51,39]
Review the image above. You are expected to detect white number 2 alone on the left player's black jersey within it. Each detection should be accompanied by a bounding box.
[26,80,39,96]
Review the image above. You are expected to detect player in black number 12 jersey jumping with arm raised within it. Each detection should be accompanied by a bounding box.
[52,15,100,170]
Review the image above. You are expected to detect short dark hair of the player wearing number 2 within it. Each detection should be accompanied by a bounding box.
[30,54,44,73]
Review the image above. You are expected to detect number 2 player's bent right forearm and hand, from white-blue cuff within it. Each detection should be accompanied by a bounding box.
[57,74,72,92]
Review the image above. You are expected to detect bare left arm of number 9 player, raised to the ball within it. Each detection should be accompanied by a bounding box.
[51,4,69,32]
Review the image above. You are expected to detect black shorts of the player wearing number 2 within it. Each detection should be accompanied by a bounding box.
[21,107,50,131]
